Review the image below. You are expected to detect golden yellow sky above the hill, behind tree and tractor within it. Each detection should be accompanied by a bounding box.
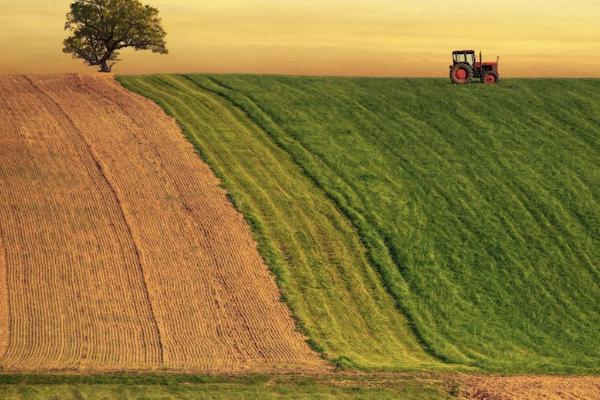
[0,0,600,77]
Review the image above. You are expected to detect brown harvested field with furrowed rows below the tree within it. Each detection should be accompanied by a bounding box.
[0,75,324,372]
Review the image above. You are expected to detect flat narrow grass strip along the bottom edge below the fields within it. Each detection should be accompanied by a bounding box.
[0,374,455,400]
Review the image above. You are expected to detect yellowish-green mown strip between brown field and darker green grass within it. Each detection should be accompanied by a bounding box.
[121,76,436,369]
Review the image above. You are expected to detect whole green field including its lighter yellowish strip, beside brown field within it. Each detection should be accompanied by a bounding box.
[119,75,600,373]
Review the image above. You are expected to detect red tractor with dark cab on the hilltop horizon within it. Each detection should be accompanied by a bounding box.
[450,50,500,85]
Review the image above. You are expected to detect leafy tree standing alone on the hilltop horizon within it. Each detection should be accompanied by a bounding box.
[63,0,167,72]
